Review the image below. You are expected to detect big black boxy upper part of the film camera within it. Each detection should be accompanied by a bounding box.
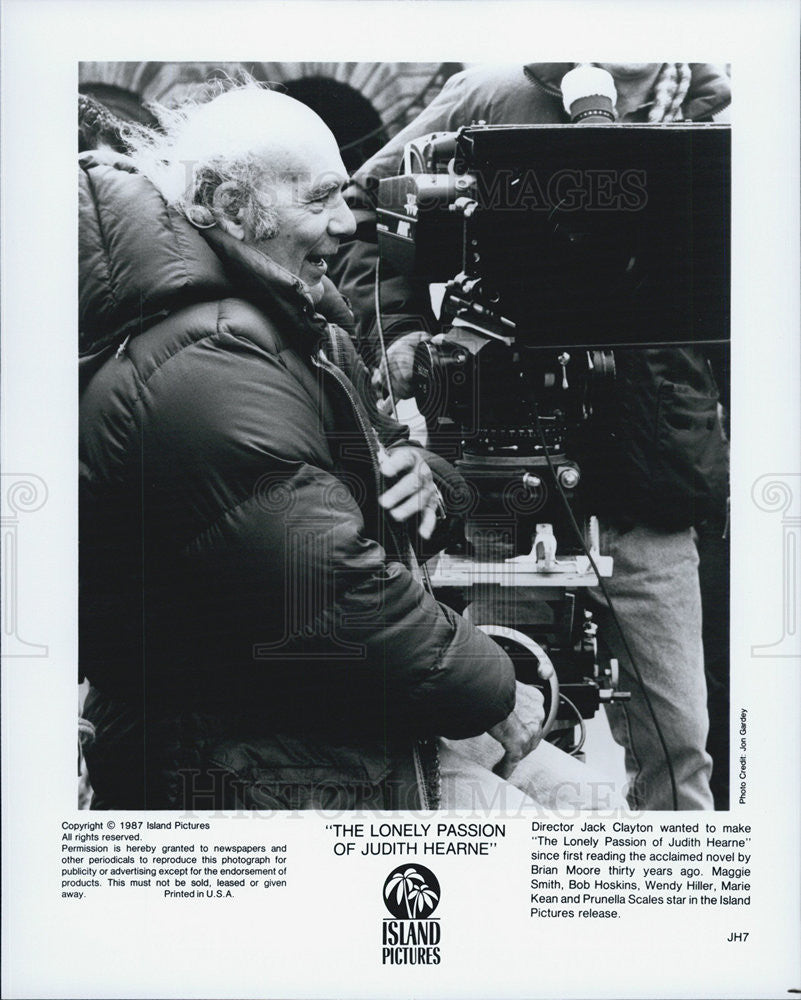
[377,124,730,349]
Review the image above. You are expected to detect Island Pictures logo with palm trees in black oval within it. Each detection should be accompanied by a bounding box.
[381,864,440,965]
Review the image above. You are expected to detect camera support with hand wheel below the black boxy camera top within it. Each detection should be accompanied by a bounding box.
[414,277,629,754]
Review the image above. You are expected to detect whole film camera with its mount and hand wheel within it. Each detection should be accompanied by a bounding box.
[377,124,730,743]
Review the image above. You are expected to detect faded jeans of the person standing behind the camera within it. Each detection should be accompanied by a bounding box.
[588,526,713,809]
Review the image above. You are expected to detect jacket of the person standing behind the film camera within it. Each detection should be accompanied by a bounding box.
[336,63,731,530]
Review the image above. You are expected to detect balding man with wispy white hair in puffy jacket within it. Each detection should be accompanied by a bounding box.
[80,85,616,809]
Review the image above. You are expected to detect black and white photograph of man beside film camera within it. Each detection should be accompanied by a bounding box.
[78,56,731,810]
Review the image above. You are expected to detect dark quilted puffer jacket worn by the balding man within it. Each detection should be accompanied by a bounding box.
[80,154,514,808]
